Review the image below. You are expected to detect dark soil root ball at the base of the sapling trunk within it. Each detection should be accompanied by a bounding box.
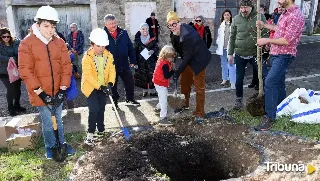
[246,93,265,116]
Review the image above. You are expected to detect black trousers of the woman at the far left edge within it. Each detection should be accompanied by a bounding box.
[0,75,21,109]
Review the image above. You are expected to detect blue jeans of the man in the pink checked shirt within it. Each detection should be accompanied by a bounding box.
[264,55,295,119]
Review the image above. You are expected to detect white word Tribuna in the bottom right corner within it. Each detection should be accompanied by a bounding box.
[265,162,306,172]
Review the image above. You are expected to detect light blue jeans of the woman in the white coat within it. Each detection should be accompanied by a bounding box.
[220,49,236,83]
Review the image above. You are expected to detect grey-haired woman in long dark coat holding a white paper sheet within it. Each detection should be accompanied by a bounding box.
[134,23,159,97]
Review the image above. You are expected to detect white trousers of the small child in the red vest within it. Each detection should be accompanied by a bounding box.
[154,84,168,118]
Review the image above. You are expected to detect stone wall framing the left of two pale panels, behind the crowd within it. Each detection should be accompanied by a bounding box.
[96,0,173,46]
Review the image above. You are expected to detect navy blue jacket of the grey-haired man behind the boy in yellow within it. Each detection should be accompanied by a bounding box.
[104,27,137,72]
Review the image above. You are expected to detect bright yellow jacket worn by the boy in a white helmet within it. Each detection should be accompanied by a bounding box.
[81,48,116,97]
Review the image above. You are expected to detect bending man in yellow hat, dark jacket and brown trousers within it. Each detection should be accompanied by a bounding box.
[167,11,211,123]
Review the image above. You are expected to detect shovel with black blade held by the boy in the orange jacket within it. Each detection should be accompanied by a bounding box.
[47,105,68,162]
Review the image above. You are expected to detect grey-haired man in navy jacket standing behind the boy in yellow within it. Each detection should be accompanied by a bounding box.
[104,14,140,108]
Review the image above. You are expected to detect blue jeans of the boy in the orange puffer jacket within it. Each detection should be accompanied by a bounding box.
[37,104,65,148]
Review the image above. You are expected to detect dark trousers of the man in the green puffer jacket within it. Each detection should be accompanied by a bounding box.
[234,54,258,98]
